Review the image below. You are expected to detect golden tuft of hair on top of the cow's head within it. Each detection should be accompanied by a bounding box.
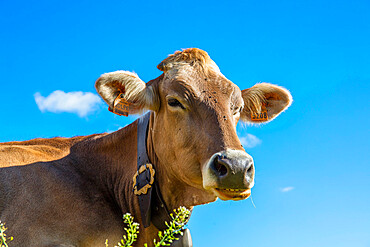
[157,48,220,74]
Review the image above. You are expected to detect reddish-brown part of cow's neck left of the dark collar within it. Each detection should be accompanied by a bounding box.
[70,122,138,218]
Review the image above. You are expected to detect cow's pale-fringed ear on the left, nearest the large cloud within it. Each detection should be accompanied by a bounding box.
[95,71,158,114]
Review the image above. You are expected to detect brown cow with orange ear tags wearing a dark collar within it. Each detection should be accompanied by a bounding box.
[0,48,292,247]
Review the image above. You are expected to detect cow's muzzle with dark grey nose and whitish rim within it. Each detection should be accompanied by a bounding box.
[202,149,254,200]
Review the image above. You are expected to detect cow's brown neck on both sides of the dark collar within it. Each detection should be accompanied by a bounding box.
[71,113,215,228]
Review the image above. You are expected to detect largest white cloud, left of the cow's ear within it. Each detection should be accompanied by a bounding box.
[34,90,102,117]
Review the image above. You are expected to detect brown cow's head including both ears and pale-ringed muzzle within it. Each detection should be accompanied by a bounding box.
[96,48,292,203]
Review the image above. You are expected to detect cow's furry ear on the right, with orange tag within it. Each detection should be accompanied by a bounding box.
[241,83,293,124]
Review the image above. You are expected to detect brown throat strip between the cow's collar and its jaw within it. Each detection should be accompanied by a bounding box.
[147,113,216,212]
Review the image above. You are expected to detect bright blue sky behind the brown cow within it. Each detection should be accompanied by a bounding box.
[0,0,370,247]
